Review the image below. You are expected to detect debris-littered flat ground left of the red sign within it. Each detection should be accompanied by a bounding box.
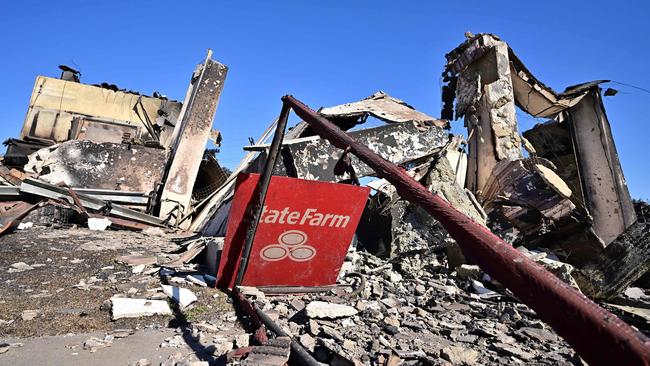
[0,226,249,365]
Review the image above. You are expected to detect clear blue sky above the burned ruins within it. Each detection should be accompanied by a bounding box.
[0,0,650,199]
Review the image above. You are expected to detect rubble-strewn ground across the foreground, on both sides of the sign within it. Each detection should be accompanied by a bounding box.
[0,227,650,365]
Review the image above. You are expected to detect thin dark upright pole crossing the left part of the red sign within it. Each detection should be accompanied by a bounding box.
[235,104,291,286]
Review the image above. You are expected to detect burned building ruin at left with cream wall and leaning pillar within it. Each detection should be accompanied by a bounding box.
[2,51,227,227]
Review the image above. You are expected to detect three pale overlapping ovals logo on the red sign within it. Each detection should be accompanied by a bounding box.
[260,230,316,262]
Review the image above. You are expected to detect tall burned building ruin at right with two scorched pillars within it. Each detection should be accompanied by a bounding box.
[443,34,636,284]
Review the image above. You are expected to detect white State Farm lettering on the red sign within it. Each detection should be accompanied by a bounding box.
[260,206,350,228]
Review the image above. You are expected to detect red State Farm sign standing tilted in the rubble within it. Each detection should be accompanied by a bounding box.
[217,174,370,288]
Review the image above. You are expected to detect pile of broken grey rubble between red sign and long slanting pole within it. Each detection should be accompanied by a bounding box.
[249,252,581,365]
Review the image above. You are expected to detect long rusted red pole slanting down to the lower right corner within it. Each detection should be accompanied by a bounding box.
[282,95,650,365]
